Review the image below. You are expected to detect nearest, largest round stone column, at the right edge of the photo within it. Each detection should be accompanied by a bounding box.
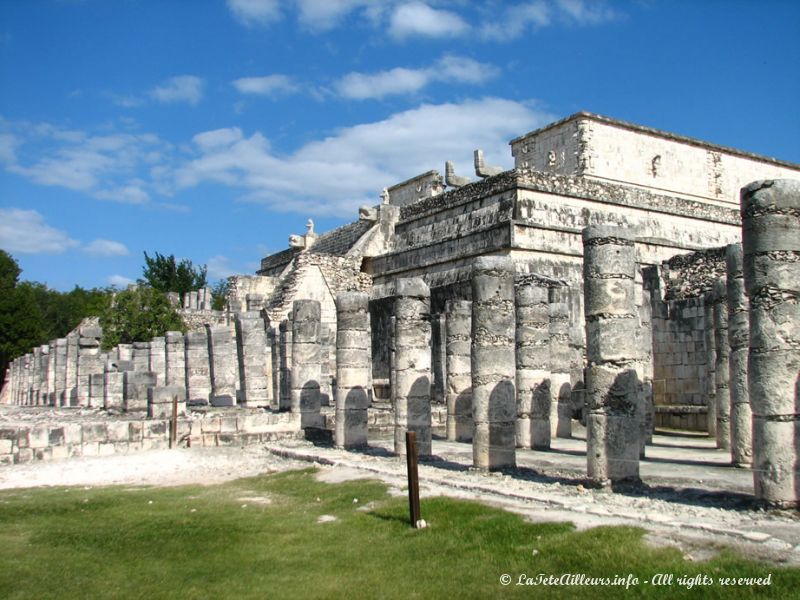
[741,179,800,506]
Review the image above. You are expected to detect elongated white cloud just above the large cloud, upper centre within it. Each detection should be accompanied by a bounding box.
[336,55,500,100]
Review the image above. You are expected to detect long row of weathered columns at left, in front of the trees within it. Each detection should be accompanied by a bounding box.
[8,312,272,408]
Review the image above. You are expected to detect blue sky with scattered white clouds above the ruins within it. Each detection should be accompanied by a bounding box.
[0,0,800,290]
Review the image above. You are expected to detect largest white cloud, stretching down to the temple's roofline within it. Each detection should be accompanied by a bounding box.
[176,98,552,217]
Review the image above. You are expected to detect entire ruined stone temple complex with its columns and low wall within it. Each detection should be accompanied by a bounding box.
[0,113,800,506]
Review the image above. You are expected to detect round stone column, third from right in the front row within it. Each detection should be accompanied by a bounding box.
[471,257,517,469]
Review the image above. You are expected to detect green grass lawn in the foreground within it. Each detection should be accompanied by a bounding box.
[0,470,800,599]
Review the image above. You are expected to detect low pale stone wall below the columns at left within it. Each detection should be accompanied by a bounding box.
[0,408,303,465]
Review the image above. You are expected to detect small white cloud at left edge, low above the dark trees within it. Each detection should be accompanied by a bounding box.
[0,208,78,254]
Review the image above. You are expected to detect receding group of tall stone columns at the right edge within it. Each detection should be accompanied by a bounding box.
[705,180,800,506]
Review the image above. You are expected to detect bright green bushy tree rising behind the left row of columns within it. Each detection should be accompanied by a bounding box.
[100,285,186,350]
